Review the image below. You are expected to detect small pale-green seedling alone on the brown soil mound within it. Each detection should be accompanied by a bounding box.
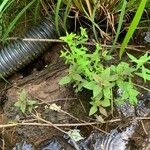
[14,89,36,113]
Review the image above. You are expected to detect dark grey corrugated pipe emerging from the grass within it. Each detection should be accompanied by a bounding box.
[0,15,63,77]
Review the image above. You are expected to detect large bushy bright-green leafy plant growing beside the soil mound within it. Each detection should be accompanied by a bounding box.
[59,28,149,115]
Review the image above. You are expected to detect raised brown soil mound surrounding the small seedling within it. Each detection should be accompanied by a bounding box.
[0,45,89,149]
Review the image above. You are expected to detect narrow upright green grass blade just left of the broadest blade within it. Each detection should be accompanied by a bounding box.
[112,0,127,50]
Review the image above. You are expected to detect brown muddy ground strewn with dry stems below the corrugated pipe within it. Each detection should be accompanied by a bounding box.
[0,31,150,150]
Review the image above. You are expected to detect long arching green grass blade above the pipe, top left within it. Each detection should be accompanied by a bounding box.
[2,0,35,41]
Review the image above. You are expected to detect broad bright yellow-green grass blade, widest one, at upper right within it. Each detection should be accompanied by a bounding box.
[119,0,147,58]
